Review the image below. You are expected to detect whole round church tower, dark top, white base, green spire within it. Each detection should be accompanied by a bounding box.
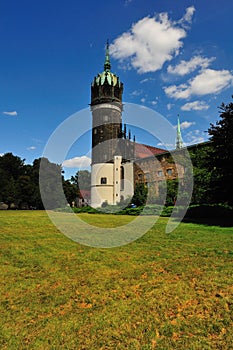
[90,42,133,207]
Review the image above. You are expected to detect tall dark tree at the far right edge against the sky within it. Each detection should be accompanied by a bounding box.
[208,96,233,205]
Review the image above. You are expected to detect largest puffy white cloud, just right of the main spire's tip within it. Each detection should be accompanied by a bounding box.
[110,7,195,73]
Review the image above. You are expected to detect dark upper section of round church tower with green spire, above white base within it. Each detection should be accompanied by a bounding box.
[91,43,123,164]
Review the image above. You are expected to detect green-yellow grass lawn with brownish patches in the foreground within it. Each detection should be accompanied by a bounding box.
[0,211,233,350]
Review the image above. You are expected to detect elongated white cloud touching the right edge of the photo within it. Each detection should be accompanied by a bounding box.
[164,69,233,99]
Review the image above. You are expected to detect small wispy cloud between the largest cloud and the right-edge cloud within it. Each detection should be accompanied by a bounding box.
[167,56,215,75]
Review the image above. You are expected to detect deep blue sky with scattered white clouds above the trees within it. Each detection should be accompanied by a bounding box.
[0,0,233,178]
